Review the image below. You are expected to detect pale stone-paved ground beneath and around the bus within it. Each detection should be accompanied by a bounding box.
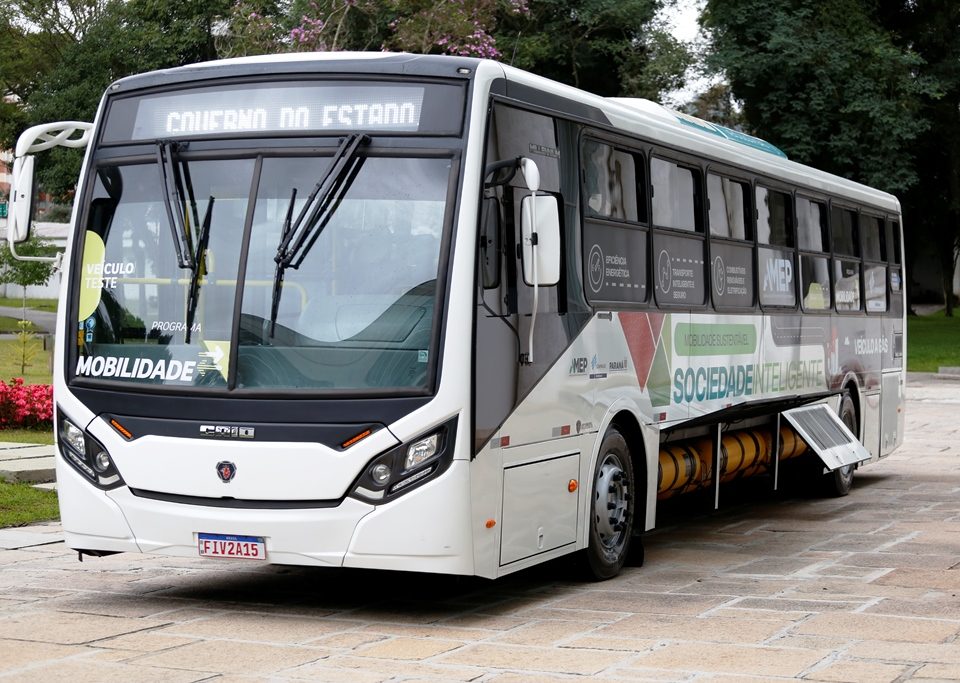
[0,377,960,683]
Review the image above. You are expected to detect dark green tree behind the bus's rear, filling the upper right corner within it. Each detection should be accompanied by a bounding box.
[702,0,960,315]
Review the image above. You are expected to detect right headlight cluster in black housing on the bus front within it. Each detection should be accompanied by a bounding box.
[350,417,457,503]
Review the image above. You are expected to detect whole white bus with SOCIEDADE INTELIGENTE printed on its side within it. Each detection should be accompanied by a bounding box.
[10,53,905,578]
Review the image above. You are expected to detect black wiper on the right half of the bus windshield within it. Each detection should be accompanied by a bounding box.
[270,133,370,337]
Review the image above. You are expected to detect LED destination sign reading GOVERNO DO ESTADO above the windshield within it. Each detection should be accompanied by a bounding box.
[104,81,463,142]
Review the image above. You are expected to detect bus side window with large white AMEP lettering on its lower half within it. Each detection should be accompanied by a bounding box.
[756,185,797,308]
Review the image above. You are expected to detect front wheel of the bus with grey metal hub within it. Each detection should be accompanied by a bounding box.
[583,428,642,581]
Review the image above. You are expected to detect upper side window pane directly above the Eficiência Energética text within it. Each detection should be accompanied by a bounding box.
[583,140,646,222]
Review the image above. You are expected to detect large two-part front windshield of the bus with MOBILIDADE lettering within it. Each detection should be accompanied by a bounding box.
[72,150,453,393]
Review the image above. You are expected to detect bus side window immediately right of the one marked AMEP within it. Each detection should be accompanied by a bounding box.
[797,196,831,311]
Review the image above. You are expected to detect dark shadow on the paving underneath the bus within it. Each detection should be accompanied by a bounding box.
[142,471,890,612]
